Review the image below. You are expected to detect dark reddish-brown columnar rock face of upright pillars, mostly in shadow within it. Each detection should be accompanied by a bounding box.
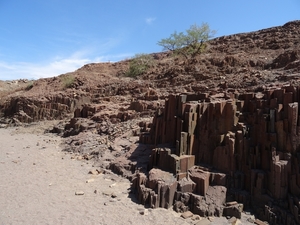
[140,86,300,224]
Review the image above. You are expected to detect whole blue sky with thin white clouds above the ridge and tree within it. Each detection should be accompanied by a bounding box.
[0,0,300,80]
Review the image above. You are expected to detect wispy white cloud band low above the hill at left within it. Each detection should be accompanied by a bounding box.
[0,38,132,80]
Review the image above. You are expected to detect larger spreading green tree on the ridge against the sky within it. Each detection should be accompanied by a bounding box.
[157,23,215,59]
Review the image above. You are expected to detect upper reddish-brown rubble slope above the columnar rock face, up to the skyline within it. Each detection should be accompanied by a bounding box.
[0,21,300,122]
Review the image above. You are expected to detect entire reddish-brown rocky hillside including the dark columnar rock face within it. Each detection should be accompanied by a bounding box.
[0,21,300,224]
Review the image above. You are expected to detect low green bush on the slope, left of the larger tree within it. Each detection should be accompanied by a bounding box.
[125,53,154,78]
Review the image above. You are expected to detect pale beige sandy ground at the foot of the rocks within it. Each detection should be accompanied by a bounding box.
[0,123,254,225]
